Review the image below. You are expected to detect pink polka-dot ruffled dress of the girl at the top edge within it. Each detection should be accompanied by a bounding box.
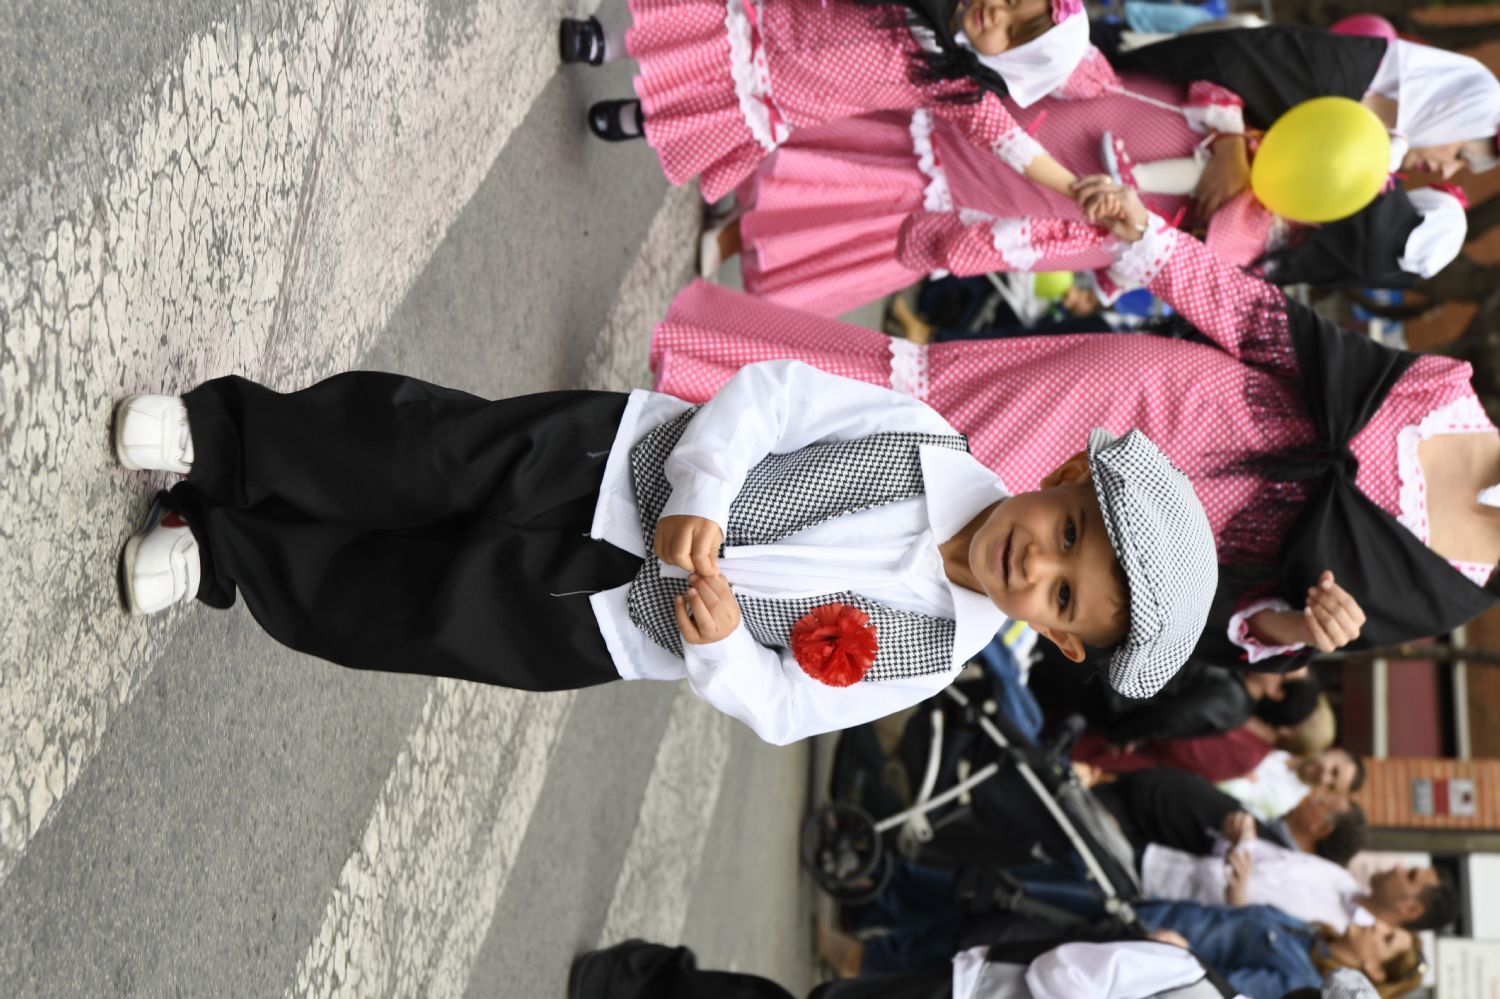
[626,0,1088,201]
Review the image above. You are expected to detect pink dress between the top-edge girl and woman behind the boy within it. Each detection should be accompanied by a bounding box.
[737,64,1248,317]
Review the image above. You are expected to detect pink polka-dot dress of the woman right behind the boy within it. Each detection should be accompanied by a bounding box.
[651,219,1496,669]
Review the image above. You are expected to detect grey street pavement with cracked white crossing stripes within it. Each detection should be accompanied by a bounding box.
[0,0,810,999]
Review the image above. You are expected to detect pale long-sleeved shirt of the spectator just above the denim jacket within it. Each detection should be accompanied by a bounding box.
[1140,840,1361,933]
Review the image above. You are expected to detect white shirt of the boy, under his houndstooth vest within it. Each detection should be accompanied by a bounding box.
[590,362,1008,744]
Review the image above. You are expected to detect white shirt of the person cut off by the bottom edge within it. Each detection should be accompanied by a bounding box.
[953,941,1248,999]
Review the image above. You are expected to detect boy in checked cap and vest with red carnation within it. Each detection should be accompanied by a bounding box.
[116,354,1215,744]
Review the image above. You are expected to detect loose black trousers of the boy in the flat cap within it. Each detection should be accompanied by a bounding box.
[164,372,641,690]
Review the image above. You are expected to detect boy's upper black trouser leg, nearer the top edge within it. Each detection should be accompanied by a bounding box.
[173,372,626,528]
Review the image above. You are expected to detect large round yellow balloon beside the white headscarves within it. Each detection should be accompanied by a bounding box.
[1250,98,1391,222]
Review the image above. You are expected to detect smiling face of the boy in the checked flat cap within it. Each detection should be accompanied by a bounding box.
[969,455,1128,660]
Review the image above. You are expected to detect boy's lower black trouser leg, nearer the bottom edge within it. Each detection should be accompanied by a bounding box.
[170,486,641,690]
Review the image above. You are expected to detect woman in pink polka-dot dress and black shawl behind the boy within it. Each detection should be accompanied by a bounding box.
[651,179,1500,671]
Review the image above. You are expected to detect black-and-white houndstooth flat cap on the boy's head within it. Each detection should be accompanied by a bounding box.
[1089,429,1218,698]
